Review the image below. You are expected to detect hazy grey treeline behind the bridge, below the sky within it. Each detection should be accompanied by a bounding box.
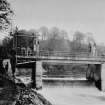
[3,26,105,55]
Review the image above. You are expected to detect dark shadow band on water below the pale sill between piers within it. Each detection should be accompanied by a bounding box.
[43,80,94,87]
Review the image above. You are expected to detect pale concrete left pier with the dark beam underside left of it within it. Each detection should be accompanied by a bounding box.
[16,61,43,89]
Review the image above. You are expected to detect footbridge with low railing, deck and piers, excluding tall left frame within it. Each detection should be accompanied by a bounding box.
[16,51,105,91]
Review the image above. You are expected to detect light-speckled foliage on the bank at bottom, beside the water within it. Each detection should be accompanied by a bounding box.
[16,88,52,105]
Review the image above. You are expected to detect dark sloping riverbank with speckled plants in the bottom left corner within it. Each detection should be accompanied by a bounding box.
[0,75,52,105]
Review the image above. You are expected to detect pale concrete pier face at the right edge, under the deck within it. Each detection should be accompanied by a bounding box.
[101,64,105,92]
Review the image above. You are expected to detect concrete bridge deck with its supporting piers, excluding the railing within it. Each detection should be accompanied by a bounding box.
[17,56,105,92]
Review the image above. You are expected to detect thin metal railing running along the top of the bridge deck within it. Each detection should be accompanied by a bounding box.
[17,50,105,58]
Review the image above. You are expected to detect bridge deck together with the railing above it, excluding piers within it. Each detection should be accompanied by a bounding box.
[17,51,105,64]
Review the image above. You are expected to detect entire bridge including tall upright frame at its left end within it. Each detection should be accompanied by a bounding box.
[13,32,105,91]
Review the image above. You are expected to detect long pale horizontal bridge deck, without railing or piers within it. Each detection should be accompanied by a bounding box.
[17,56,105,64]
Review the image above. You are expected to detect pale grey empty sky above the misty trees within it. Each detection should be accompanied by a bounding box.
[8,0,105,44]
